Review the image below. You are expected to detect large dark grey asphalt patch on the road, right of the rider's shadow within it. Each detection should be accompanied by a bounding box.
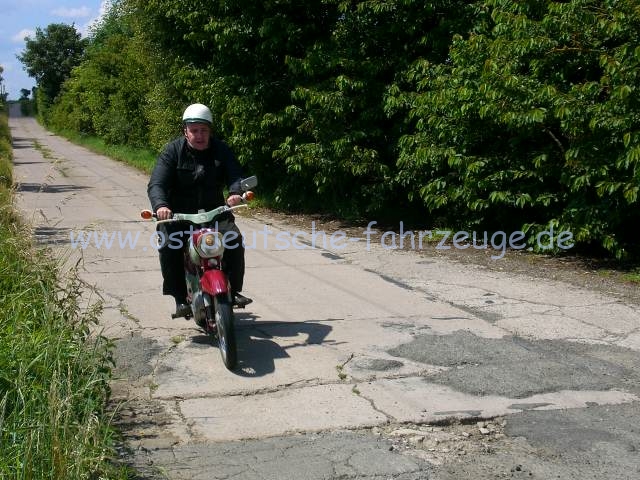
[388,331,640,398]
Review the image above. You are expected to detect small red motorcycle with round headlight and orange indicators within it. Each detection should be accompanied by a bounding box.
[140,176,258,370]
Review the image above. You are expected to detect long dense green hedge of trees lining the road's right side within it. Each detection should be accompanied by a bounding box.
[36,0,640,257]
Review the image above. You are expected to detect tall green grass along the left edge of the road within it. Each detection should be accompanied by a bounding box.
[0,109,127,480]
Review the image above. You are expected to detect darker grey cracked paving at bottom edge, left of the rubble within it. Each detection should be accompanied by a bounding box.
[129,430,431,480]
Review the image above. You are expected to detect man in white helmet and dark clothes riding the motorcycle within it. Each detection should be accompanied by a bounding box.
[147,103,252,317]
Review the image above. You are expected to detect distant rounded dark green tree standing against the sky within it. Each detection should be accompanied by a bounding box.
[17,23,86,109]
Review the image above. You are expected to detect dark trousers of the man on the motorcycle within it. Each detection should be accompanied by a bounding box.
[158,220,244,300]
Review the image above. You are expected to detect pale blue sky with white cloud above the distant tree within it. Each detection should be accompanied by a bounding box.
[0,0,109,100]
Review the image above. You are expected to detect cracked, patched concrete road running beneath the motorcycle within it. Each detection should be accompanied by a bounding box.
[10,106,640,479]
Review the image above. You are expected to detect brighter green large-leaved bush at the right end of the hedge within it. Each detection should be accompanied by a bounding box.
[387,0,640,254]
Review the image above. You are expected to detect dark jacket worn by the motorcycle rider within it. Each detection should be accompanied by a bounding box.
[147,137,242,213]
